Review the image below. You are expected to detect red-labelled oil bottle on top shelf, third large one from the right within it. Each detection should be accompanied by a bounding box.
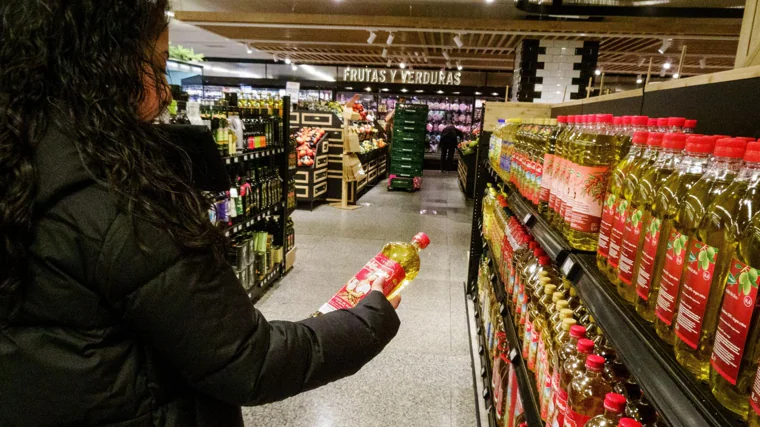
[652,137,715,345]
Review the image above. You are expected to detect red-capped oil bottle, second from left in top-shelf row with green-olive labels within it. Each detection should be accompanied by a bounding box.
[607,132,663,287]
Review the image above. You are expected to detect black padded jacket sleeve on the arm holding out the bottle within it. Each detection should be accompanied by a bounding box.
[96,217,399,406]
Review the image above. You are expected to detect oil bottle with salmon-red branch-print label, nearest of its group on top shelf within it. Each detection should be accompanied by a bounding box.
[567,114,615,251]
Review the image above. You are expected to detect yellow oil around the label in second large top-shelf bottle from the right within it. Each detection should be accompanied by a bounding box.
[675,158,741,381]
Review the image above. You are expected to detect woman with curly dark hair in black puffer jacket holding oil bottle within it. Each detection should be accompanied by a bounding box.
[0,0,399,427]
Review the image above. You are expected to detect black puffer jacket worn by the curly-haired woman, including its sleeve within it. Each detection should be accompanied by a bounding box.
[0,123,399,427]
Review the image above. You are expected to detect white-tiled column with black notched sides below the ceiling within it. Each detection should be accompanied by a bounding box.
[512,39,599,104]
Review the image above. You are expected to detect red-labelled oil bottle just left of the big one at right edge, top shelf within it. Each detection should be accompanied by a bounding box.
[675,139,746,381]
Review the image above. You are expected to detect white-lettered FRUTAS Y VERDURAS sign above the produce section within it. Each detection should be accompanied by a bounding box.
[343,68,462,86]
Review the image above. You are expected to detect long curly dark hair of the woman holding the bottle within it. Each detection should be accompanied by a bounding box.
[0,0,224,303]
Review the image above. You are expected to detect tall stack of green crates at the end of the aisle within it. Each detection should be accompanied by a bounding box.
[388,104,428,190]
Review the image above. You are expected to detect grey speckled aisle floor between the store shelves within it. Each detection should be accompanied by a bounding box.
[243,171,476,427]
